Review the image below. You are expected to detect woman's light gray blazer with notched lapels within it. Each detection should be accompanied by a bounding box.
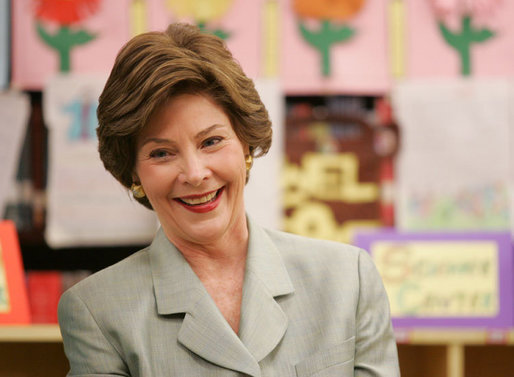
[59,219,399,377]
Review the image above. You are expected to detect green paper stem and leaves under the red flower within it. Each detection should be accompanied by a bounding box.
[36,22,96,72]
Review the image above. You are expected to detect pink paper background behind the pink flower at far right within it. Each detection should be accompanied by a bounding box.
[405,0,514,78]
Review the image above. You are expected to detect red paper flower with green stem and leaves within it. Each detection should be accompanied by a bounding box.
[34,0,100,72]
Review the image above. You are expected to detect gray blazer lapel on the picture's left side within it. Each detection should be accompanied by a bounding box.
[150,229,260,376]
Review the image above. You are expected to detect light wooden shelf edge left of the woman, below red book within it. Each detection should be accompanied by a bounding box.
[0,324,62,343]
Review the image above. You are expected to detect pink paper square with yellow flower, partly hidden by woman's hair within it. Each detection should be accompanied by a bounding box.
[146,0,266,79]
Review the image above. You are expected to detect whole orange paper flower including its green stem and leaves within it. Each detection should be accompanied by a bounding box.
[293,0,365,76]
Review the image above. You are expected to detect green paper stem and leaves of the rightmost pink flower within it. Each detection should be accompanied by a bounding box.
[439,15,494,76]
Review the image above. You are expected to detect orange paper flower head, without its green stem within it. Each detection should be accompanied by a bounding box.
[293,0,365,21]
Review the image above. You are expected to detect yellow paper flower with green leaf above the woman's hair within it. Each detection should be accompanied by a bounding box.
[168,0,233,39]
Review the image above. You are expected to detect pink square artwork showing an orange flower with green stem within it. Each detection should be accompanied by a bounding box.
[280,0,390,94]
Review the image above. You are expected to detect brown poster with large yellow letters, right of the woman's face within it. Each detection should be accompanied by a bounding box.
[282,98,394,242]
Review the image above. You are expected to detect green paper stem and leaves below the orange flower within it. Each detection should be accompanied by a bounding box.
[298,20,355,77]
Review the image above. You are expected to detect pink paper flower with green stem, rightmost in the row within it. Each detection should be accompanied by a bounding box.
[429,0,503,76]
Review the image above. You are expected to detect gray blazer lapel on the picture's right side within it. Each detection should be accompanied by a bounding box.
[239,219,294,362]
